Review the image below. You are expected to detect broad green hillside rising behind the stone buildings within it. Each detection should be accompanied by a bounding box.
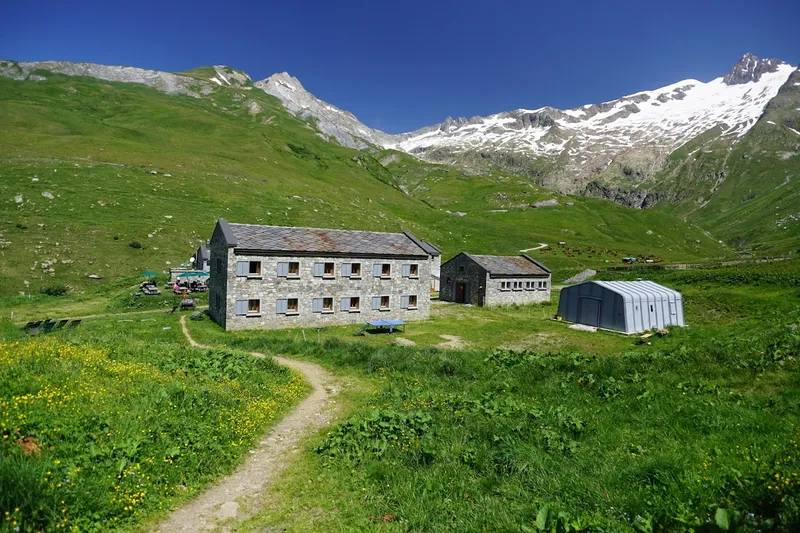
[0,69,730,294]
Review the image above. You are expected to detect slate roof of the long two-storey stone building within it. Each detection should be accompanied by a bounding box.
[219,219,427,257]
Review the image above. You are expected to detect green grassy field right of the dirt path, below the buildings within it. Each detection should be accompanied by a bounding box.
[173,262,800,532]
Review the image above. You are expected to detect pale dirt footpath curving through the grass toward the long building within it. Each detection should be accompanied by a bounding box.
[154,316,339,533]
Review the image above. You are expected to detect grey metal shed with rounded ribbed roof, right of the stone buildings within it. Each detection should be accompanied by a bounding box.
[558,281,686,333]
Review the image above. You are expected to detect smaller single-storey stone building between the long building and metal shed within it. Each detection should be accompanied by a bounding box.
[439,252,550,306]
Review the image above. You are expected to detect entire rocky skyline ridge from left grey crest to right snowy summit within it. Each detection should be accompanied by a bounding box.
[0,54,796,207]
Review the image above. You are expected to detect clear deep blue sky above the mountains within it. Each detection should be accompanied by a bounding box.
[0,0,800,133]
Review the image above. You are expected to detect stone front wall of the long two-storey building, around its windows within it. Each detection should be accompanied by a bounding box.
[219,252,430,330]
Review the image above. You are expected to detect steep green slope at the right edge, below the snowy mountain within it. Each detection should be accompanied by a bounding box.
[655,72,800,252]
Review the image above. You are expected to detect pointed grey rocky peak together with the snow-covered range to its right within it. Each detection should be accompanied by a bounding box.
[256,54,795,192]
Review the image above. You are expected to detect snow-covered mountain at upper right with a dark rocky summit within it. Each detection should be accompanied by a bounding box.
[384,54,795,191]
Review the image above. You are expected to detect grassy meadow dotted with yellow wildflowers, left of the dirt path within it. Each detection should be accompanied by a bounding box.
[0,315,307,532]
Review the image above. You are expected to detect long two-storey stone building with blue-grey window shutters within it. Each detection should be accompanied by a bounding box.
[209,219,431,330]
